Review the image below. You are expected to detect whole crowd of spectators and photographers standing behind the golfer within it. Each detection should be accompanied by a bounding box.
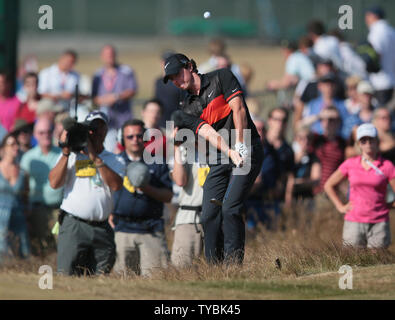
[0,7,395,276]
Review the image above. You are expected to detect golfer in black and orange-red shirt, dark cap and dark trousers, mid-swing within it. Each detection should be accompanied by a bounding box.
[163,53,263,263]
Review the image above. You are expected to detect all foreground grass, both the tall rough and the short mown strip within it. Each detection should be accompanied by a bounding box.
[0,201,395,299]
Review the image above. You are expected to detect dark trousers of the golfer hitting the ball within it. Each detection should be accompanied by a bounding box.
[201,140,263,264]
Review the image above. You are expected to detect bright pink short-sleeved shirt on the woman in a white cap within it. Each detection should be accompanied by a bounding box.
[339,156,395,223]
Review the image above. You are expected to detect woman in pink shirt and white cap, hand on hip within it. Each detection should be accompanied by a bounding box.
[324,123,395,248]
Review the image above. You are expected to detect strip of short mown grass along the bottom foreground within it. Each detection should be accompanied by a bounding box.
[0,264,395,300]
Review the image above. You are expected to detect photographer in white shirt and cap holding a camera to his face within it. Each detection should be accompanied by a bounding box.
[49,111,125,275]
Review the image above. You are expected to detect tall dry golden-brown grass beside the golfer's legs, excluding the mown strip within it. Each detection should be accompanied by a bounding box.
[155,200,395,281]
